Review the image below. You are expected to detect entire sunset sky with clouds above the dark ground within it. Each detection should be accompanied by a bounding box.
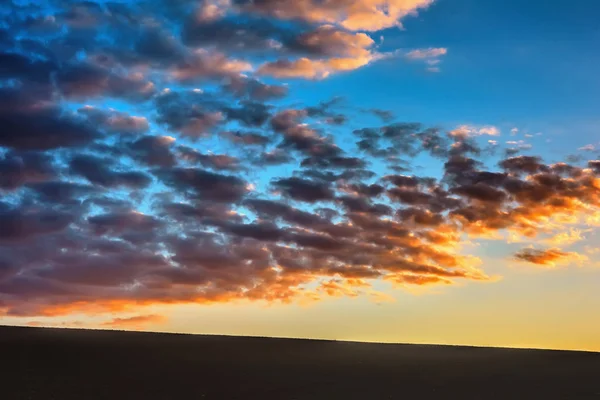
[0,0,600,351]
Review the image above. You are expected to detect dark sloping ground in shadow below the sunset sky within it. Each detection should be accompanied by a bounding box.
[0,327,600,400]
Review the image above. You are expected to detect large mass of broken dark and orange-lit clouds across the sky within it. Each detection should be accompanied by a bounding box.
[0,0,600,318]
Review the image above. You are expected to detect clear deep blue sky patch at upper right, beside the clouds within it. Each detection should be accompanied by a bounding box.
[292,0,600,151]
